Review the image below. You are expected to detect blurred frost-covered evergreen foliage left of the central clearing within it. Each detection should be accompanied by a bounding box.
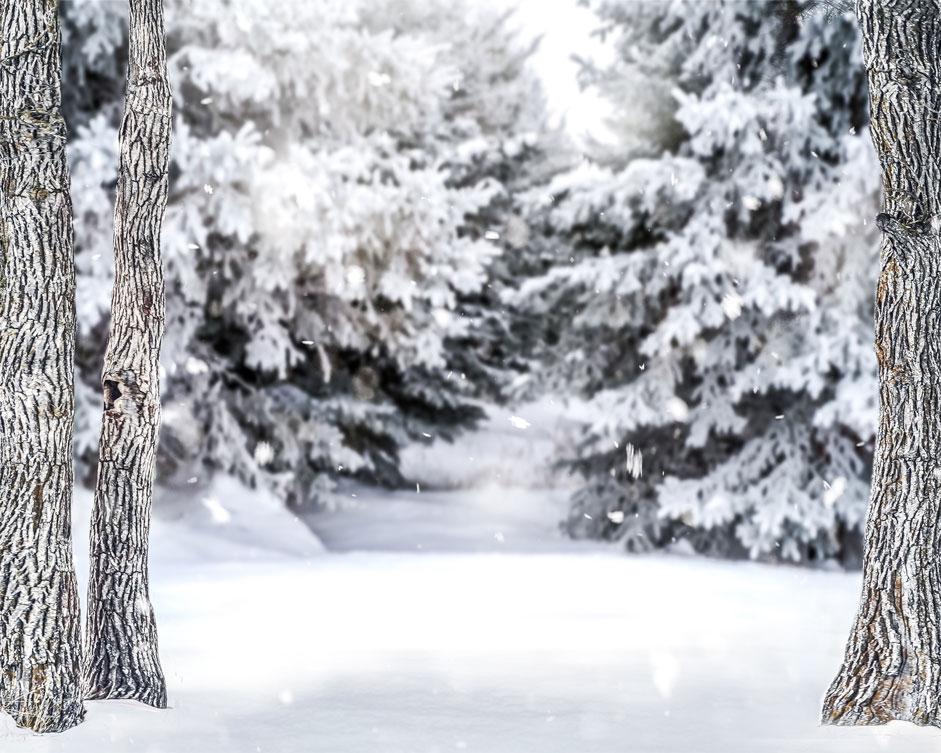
[66,0,542,503]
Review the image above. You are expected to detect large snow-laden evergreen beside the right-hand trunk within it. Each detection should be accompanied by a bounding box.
[517,0,878,560]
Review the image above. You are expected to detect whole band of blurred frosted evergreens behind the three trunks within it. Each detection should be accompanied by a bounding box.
[64,0,878,562]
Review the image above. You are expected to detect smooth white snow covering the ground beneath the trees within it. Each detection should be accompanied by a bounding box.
[0,480,941,753]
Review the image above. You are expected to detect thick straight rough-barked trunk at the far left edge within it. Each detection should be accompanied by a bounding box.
[0,0,85,732]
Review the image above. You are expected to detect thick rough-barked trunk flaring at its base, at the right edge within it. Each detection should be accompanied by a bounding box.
[823,0,941,726]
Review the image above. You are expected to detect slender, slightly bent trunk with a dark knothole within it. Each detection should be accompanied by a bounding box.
[85,0,171,708]
